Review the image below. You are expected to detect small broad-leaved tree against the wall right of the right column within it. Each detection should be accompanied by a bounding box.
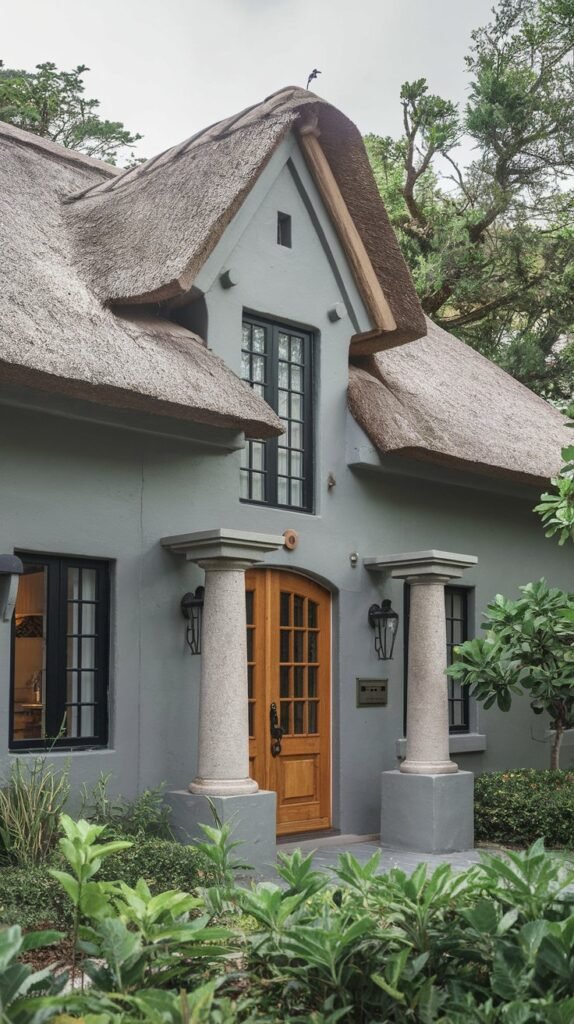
[447,580,574,769]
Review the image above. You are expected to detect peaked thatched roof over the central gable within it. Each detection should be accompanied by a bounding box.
[67,87,425,344]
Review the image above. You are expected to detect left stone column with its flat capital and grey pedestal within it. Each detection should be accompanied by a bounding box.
[162,529,284,865]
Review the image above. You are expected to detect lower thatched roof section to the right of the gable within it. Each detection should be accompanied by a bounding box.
[349,321,574,483]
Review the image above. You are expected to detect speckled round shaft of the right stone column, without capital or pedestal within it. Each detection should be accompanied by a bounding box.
[400,574,458,775]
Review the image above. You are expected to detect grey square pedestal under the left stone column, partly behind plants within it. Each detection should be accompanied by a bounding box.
[164,790,277,867]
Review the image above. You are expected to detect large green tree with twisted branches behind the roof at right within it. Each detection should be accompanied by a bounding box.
[365,0,574,402]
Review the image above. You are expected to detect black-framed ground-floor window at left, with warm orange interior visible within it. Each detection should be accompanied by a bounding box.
[10,552,109,750]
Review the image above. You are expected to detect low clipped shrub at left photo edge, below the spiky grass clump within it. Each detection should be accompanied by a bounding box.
[0,865,72,930]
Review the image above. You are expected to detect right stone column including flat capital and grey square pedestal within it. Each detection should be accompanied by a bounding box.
[365,550,477,853]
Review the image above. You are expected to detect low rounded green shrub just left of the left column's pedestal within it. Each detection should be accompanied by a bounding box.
[98,838,212,893]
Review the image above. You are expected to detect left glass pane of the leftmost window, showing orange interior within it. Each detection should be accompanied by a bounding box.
[12,564,48,739]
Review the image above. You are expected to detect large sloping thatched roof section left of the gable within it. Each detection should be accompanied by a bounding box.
[0,125,281,436]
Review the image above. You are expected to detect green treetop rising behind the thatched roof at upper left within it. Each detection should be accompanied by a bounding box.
[0,60,142,164]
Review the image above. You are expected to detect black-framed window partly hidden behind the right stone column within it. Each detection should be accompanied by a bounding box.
[404,585,471,733]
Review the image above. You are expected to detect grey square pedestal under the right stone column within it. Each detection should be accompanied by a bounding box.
[381,771,474,853]
